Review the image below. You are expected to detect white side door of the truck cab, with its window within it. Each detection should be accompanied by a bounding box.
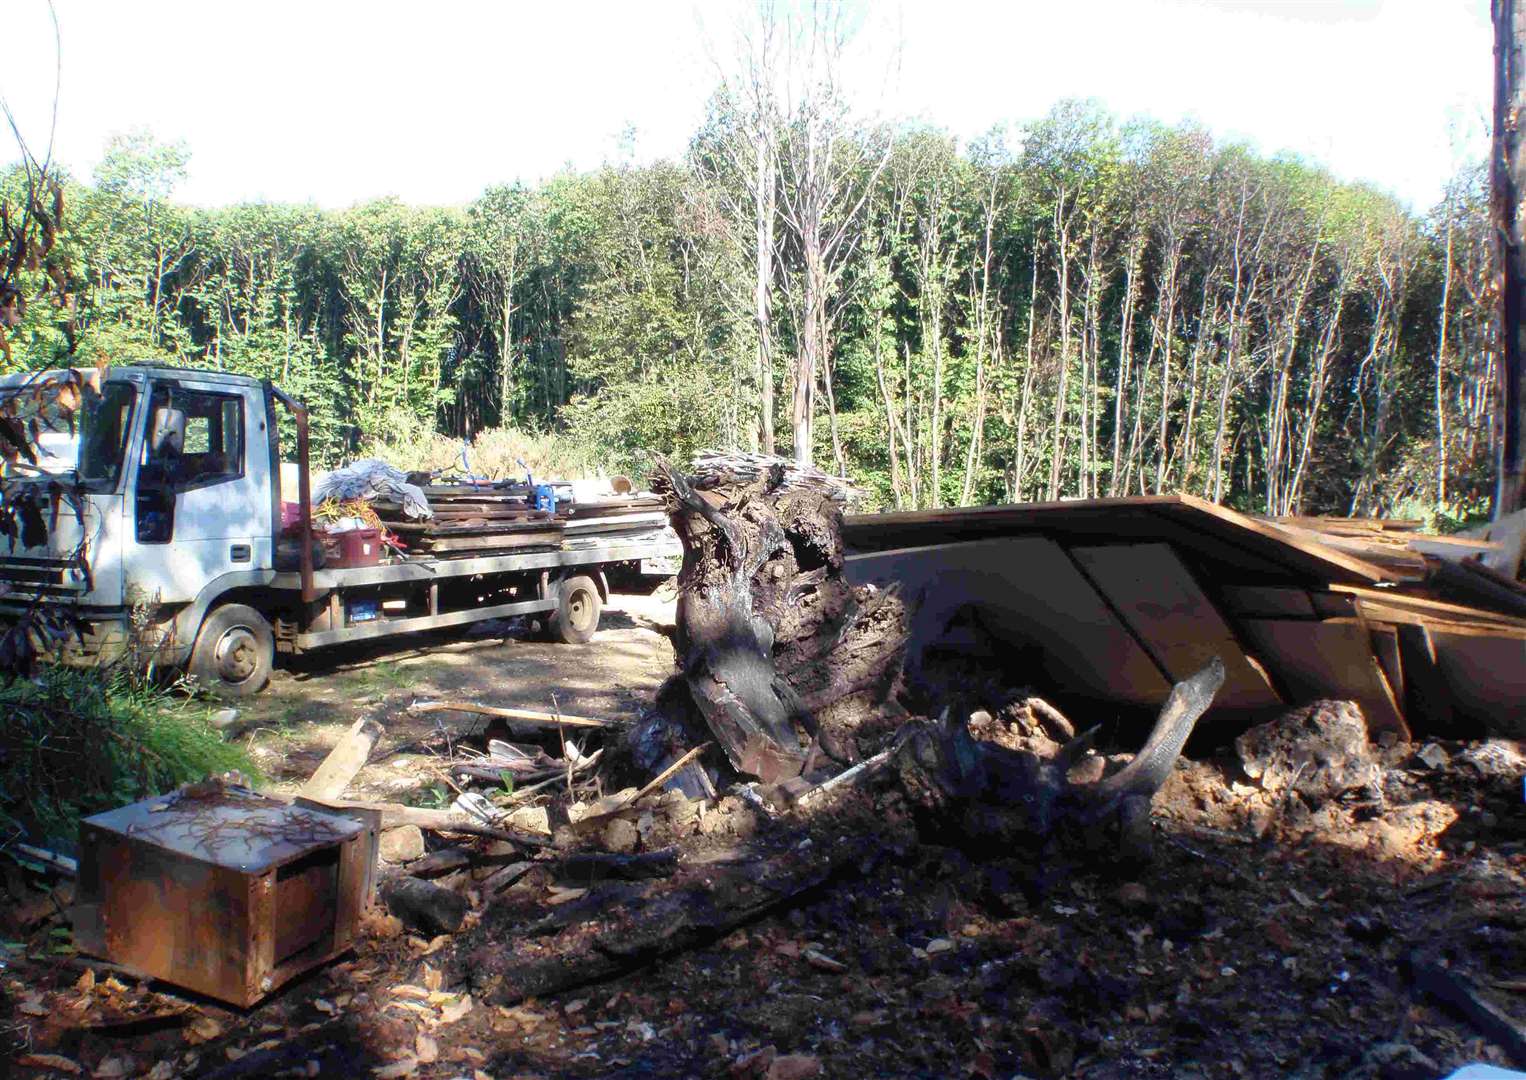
[125,381,273,604]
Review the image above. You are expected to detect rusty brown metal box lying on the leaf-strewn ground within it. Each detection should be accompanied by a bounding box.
[73,786,374,1007]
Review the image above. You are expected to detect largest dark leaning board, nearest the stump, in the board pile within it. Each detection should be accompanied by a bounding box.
[845,537,1170,706]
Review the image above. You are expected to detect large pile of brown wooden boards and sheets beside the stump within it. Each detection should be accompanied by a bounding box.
[844,496,1526,738]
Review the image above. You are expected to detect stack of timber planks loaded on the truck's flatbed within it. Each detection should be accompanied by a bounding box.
[374,481,667,557]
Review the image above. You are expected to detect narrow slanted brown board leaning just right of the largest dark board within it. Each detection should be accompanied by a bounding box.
[1070,543,1283,709]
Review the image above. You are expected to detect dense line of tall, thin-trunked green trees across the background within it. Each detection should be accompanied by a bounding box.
[8,99,1495,514]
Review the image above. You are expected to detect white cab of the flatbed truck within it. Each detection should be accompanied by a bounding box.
[0,366,281,665]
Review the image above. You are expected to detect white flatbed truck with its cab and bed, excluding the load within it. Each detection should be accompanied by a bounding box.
[0,365,678,697]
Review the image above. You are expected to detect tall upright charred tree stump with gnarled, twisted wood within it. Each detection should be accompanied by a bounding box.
[633,459,905,795]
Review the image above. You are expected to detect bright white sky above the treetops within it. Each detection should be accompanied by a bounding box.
[0,0,1491,209]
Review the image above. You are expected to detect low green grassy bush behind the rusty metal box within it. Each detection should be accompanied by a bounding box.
[0,667,256,851]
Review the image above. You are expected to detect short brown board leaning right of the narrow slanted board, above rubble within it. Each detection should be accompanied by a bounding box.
[1239,619,1408,738]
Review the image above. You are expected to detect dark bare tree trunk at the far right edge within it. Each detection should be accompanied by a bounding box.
[1489,0,1526,519]
